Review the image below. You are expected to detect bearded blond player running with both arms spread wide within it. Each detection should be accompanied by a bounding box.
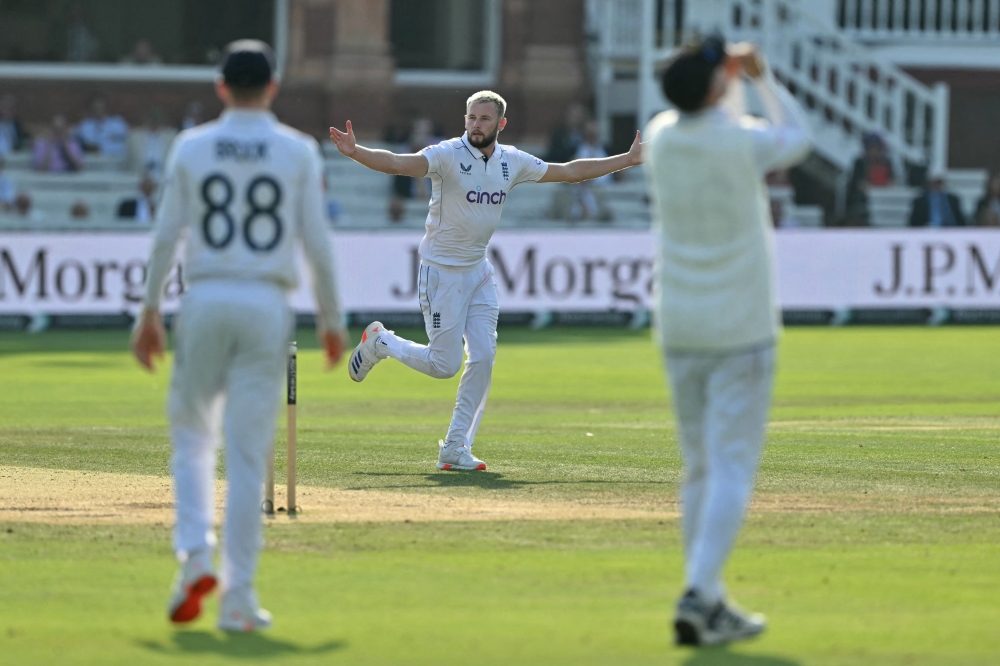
[330,90,640,470]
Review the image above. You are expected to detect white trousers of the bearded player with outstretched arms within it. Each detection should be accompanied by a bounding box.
[382,259,500,449]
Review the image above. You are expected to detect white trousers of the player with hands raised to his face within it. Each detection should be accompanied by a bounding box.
[666,344,775,600]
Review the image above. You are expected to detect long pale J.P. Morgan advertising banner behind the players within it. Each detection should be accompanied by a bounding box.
[0,229,1000,328]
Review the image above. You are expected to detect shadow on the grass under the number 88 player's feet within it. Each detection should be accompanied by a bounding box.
[139,631,347,659]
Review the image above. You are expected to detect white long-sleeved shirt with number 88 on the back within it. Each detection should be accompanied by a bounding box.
[145,109,342,330]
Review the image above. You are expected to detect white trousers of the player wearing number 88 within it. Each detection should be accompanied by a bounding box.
[168,280,292,590]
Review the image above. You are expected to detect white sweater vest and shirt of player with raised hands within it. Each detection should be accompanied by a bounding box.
[645,75,811,351]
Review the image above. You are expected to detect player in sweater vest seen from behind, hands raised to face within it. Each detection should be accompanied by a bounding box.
[645,37,811,645]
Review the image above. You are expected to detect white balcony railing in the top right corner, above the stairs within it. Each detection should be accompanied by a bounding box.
[835,0,1000,41]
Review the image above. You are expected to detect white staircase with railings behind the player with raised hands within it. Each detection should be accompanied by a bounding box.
[588,0,948,170]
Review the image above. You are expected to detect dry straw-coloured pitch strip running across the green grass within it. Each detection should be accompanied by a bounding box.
[0,466,1000,525]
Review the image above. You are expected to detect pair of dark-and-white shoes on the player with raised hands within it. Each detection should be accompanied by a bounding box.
[674,589,767,646]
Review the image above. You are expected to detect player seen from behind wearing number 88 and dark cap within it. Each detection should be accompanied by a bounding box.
[132,40,348,631]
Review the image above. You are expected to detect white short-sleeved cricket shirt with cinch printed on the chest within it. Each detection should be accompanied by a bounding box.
[420,133,549,266]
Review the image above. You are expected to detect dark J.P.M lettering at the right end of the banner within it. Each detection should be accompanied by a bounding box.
[872,241,1000,300]
